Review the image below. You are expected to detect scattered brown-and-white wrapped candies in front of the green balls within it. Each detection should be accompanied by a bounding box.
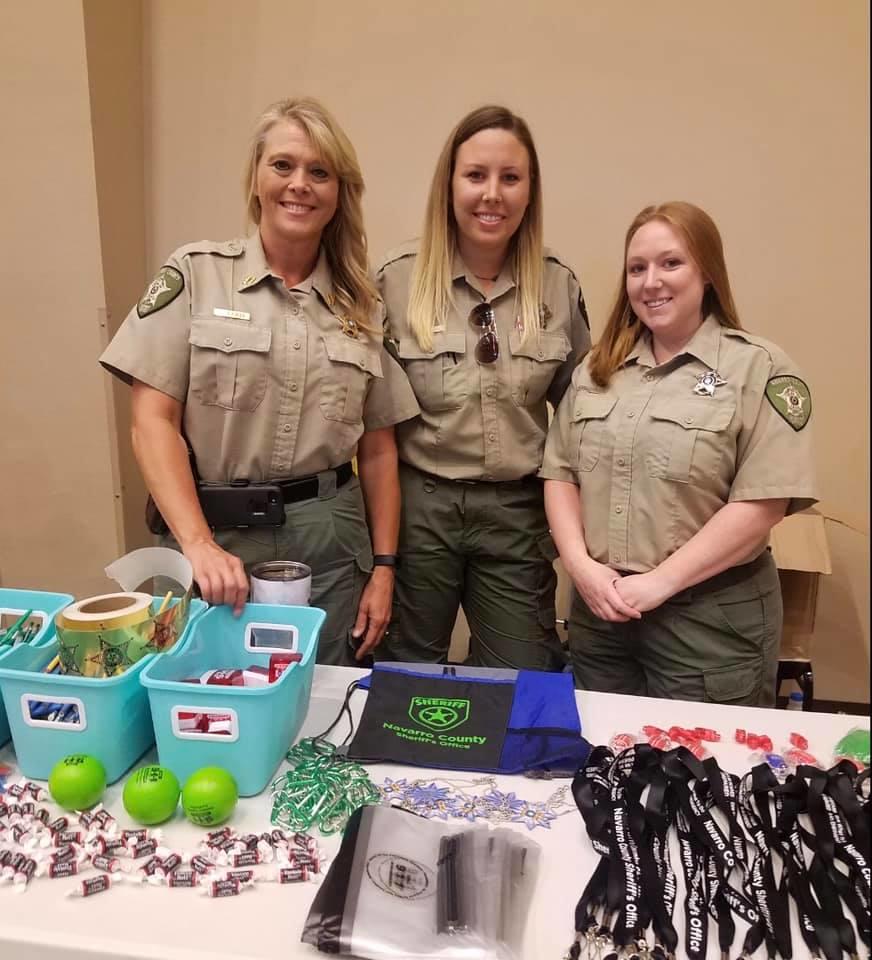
[0,780,326,897]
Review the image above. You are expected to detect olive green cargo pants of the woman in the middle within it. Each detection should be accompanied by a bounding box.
[376,463,562,670]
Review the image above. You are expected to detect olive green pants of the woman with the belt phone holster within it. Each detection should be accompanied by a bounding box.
[163,470,372,666]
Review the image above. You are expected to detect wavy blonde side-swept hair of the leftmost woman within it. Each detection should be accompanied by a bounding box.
[244,97,381,333]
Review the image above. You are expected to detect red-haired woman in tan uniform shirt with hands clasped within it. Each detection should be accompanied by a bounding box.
[542,202,817,706]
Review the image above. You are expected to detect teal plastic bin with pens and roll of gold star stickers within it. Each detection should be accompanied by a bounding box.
[0,597,208,783]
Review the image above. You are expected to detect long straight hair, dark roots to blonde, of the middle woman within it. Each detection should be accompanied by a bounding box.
[409,106,544,350]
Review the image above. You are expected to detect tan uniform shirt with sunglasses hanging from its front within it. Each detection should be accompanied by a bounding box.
[377,242,590,480]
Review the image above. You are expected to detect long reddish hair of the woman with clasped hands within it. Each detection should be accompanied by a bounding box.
[589,200,742,387]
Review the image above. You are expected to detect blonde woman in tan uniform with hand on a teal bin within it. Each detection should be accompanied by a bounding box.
[101,99,418,663]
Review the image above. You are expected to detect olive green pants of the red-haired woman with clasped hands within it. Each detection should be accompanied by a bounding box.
[569,550,783,707]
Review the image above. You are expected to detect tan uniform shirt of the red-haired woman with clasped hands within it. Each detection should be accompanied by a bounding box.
[541,317,817,573]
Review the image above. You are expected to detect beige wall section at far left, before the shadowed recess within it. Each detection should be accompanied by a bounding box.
[0,2,121,596]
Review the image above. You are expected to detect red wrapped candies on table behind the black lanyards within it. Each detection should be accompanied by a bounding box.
[609,725,819,779]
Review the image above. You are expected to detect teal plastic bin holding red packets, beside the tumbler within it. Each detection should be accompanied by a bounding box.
[142,603,326,797]
